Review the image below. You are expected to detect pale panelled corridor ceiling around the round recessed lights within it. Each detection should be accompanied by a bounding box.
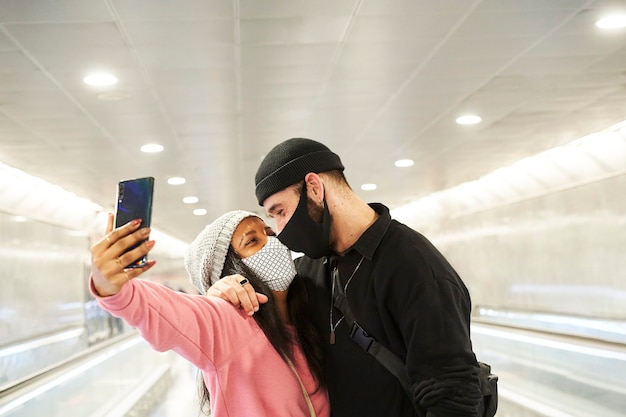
[0,0,626,241]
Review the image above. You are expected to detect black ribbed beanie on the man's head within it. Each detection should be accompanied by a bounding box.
[254,138,344,206]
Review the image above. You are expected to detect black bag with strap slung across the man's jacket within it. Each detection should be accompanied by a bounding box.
[333,285,498,417]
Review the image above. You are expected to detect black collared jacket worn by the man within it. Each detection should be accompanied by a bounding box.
[296,204,481,417]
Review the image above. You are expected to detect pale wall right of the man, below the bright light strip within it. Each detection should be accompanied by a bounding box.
[412,175,626,320]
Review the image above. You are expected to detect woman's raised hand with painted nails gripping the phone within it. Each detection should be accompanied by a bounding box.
[91,214,156,297]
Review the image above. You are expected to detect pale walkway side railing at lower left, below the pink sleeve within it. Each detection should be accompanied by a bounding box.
[0,332,170,417]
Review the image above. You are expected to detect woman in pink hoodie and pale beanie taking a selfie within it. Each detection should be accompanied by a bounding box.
[90,210,330,417]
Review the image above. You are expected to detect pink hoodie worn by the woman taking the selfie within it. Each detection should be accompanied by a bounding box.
[90,279,330,417]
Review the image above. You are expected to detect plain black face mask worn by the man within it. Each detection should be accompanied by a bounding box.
[277,187,333,259]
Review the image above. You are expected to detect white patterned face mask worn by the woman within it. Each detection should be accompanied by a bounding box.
[241,236,296,291]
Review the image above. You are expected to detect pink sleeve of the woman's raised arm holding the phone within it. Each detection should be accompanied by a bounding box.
[90,279,259,369]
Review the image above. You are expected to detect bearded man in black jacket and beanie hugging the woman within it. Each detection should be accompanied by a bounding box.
[209,138,481,417]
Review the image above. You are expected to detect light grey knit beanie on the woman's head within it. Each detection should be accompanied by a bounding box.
[185,210,260,294]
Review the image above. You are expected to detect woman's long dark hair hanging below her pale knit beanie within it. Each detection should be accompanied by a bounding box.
[198,247,326,415]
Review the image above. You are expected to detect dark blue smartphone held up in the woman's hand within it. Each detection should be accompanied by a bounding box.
[115,177,154,268]
